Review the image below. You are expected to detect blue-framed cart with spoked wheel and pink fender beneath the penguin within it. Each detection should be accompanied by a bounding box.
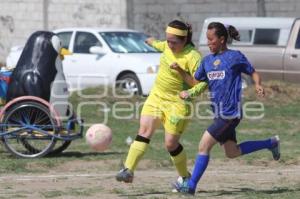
[0,96,83,158]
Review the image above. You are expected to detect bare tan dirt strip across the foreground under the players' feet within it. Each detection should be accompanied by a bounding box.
[0,160,300,199]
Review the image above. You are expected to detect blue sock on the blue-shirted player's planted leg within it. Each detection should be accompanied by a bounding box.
[188,154,209,191]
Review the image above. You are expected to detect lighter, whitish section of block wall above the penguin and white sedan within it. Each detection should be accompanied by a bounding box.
[0,0,127,63]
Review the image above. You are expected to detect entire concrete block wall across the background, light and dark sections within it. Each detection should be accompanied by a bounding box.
[0,0,300,62]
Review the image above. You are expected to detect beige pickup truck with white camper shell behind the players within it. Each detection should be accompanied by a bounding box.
[199,17,300,83]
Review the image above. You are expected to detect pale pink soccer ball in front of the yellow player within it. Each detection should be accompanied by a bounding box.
[85,124,112,151]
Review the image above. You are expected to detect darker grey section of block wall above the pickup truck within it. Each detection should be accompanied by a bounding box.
[128,0,300,44]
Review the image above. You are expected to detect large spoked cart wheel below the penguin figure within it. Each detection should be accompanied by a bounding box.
[2,101,58,158]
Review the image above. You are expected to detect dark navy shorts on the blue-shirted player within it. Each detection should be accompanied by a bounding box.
[207,118,240,144]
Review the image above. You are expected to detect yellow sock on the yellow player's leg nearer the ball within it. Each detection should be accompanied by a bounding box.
[124,140,149,171]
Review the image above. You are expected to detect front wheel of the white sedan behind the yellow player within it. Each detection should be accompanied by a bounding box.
[116,73,142,95]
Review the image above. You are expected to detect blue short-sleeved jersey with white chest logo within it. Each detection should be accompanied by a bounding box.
[195,50,255,118]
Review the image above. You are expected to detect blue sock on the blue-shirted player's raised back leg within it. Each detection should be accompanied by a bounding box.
[239,139,272,155]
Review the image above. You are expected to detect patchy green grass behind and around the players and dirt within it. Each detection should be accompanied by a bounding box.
[0,82,300,199]
